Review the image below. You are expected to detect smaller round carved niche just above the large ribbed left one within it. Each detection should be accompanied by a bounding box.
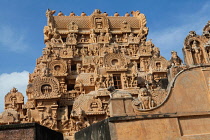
[49,59,67,76]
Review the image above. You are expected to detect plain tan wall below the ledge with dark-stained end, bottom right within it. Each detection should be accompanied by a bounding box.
[75,113,210,140]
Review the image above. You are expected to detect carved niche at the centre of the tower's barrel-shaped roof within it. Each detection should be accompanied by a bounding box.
[91,9,109,33]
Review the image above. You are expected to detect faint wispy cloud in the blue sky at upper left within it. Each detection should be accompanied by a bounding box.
[0,25,28,52]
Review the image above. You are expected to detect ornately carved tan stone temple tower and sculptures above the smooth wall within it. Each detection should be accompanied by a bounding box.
[6,9,210,139]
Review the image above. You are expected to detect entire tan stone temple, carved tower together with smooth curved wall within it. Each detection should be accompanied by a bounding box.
[0,9,210,140]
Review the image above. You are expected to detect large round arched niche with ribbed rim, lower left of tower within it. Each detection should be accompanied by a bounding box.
[32,77,60,99]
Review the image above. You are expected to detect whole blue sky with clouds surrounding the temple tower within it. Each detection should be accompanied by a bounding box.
[0,0,210,112]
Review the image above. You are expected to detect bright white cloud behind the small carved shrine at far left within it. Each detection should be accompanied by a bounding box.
[0,71,29,112]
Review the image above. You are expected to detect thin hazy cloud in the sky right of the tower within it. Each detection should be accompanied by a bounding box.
[148,2,210,59]
